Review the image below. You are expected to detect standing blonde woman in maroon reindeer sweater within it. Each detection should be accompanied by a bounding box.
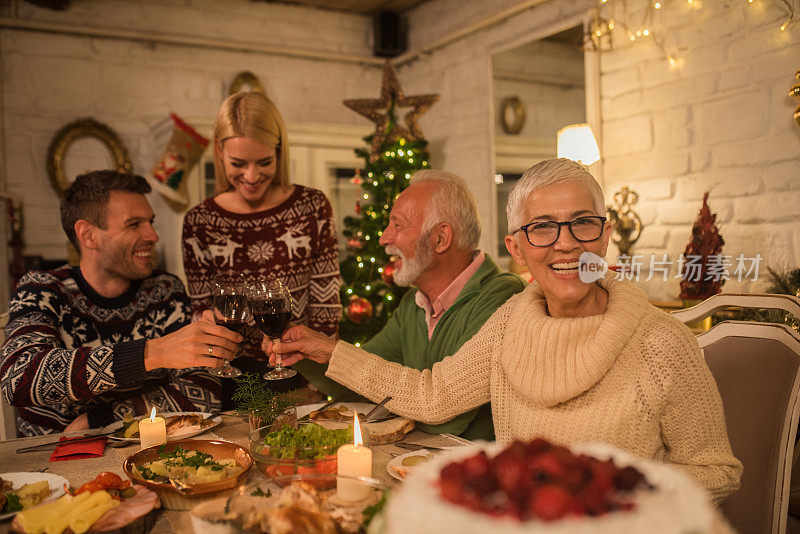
[183,93,341,400]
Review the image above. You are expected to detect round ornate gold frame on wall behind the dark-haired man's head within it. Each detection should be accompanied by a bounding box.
[47,117,131,196]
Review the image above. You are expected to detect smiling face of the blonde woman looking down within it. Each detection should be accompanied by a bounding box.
[219,137,278,204]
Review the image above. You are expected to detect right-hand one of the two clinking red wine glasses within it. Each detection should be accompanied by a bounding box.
[250,278,297,380]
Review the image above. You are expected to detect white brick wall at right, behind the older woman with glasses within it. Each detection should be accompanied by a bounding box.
[601,1,800,299]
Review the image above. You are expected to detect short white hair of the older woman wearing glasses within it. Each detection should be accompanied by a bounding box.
[506,158,606,233]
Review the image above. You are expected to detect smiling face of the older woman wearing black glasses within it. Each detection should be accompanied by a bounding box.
[506,182,610,313]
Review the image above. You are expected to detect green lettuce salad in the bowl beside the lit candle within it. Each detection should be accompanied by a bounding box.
[264,423,353,460]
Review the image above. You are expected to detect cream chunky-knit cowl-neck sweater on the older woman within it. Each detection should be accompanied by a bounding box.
[327,273,742,502]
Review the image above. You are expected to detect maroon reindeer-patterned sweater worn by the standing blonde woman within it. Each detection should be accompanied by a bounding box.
[183,185,341,394]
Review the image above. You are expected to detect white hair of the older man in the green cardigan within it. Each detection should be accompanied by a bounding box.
[411,169,481,250]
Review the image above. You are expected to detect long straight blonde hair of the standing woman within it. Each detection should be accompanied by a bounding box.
[214,93,290,194]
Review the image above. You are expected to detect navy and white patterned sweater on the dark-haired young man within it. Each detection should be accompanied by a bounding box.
[0,266,221,436]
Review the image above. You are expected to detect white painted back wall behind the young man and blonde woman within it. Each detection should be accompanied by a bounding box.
[0,0,380,276]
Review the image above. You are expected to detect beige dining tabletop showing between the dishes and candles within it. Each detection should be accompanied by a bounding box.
[0,413,470,534]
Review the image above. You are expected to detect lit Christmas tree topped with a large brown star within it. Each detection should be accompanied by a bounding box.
[339,62,439,345]
